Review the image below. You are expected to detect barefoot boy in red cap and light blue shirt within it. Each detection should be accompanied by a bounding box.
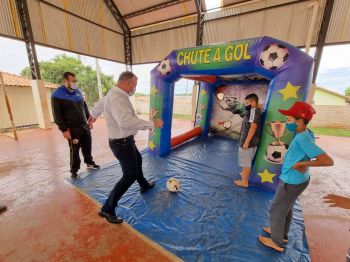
[259,101,333,252]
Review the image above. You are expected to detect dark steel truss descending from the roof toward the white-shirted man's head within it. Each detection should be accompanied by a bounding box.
[104,0,132,71]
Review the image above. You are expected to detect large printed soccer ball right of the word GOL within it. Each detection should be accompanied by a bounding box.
[260,44,289,70]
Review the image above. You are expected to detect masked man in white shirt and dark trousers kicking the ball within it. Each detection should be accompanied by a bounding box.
[89,71,163,224]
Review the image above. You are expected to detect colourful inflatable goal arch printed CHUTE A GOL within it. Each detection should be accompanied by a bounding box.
[149,37,313,191]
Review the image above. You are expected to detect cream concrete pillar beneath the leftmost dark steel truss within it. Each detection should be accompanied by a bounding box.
[31,80,52,129]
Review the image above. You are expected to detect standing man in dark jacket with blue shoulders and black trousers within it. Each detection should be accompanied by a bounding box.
[51,72,100,179]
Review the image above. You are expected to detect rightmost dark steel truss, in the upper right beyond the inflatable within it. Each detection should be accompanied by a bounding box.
[312,0,334,83]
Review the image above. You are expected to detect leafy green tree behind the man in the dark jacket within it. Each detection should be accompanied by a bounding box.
[21,55,114,107]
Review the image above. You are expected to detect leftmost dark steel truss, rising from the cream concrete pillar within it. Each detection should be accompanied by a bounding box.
[16,0,41,80]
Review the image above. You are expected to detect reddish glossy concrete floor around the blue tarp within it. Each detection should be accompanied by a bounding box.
[0,119,350,262]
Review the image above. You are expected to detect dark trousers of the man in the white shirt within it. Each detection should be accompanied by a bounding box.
[101,136,148,214]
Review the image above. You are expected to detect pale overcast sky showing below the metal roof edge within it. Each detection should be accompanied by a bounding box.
[0,37,350,94]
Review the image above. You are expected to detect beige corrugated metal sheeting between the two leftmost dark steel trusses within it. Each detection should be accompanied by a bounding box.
[28,0,124,62]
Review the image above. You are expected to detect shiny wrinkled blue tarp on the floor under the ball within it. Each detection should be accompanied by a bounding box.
[71,137,310,262]
